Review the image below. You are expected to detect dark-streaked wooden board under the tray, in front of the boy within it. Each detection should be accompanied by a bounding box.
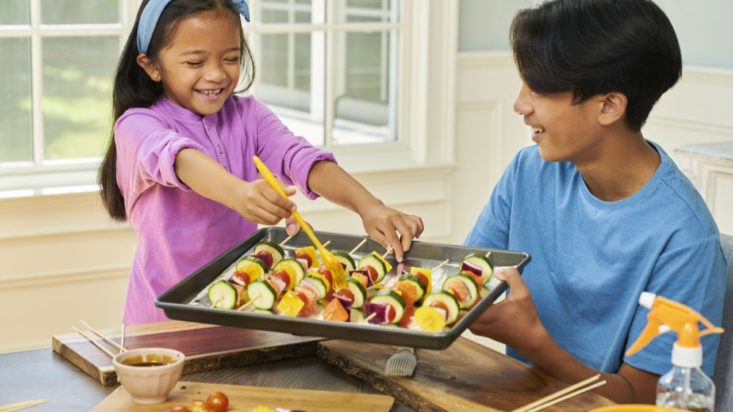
[317,338,613,412]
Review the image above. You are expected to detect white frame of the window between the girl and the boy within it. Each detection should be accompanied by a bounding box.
[246,0,459,171]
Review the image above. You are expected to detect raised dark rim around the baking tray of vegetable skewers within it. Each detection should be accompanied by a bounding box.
[155,227,531,349]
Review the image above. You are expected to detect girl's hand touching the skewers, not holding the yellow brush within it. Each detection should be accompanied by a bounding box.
[361,204,424,262]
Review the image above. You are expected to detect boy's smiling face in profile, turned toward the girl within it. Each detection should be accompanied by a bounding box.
[514,83,603,164]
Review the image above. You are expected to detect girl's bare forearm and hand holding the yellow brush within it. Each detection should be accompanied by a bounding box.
[175,149,295,225]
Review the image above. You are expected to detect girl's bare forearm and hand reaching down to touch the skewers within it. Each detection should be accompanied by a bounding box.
[308,161,424,262]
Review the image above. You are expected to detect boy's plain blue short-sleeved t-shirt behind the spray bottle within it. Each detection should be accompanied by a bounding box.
[465,143,726,376]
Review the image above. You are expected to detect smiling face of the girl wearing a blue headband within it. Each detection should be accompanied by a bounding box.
[143,12,242,116]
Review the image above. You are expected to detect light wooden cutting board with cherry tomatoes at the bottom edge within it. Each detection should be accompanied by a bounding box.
[94,381,394,412]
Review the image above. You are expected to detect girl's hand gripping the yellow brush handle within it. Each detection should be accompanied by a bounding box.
[233,179,295,225]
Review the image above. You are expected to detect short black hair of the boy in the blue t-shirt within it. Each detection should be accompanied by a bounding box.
[509,0,682,131]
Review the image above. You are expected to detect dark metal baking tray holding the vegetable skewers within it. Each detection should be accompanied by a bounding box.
[155,227,530,349]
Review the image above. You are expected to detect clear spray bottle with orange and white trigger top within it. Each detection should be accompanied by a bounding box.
[626,292,723,412]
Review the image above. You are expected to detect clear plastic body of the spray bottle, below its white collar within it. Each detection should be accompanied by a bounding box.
[656,366,715,412]
